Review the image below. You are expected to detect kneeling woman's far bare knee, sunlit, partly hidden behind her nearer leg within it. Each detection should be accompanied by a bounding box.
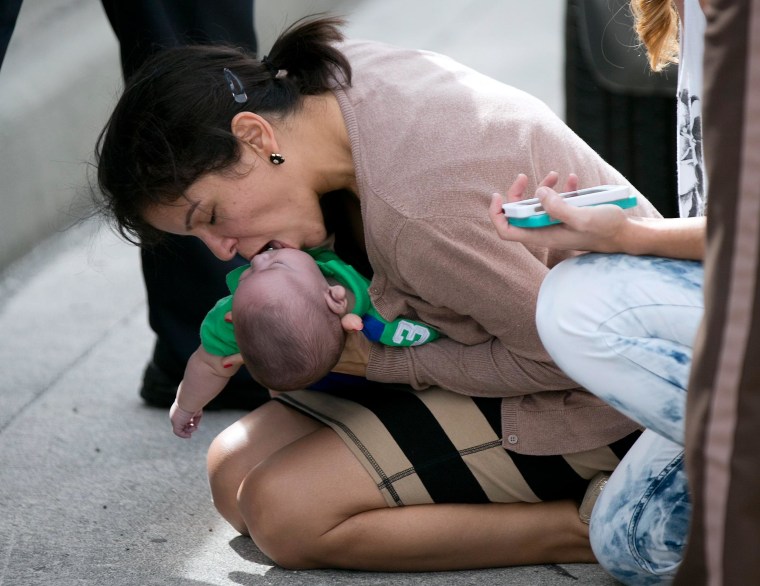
[207,401,324,535]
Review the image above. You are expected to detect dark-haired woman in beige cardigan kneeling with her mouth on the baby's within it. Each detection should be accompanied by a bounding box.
[98,18,659,571]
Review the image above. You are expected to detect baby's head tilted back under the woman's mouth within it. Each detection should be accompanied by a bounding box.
[232,248,347,391]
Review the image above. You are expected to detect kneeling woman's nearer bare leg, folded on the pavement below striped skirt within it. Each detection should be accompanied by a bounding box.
[238,428,595,571]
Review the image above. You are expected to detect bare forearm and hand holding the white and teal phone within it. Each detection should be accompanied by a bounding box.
[489,175,706,260]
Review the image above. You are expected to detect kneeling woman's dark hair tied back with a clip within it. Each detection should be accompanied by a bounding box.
[95,17,351,244]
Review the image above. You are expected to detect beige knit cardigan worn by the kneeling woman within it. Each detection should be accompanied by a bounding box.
[335,42,659,454]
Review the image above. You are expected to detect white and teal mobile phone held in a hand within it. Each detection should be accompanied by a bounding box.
[502,185,637,228]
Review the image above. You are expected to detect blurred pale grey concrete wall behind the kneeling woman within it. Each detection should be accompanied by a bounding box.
[0,0,564,270]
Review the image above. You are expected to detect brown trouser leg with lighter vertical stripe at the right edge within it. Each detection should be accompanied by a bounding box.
[676,0,760,586]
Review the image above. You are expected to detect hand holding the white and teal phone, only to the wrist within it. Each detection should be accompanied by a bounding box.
[489,173,630,252]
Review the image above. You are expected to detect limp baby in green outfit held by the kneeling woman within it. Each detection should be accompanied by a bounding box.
[170,248,439,438]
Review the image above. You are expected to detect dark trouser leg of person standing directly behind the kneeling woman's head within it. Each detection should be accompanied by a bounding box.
[102,0,268,408]
